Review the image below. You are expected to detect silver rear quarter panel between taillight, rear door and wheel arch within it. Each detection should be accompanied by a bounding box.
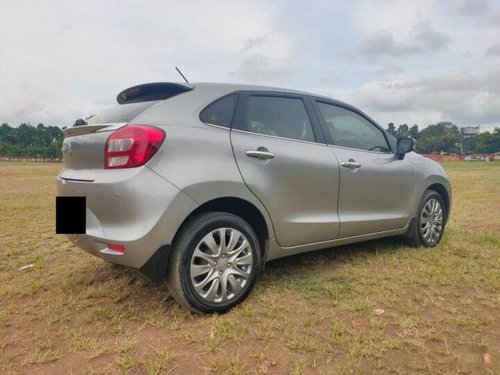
[143,111,274,238]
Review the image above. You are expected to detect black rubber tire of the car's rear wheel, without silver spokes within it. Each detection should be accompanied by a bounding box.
[167,212,262,313]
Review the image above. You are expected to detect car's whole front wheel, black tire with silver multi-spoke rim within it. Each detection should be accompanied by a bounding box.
[406,190,447,247]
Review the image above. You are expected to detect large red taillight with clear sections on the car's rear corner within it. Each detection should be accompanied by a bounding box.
[104,125,165,169]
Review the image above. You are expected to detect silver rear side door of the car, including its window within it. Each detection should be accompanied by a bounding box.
[231,92,339,247]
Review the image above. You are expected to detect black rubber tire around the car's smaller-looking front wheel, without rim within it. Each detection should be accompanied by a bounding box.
[405,190,448,247]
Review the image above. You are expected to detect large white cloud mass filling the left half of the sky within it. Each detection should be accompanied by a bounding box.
[0,0,292,125]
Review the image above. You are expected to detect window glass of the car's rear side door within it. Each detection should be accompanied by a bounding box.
[239,95,315,142]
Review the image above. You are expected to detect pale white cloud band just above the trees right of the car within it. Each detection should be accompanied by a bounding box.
[339,66,500,129]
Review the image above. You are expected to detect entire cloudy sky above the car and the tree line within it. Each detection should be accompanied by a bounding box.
[0,0,500,130]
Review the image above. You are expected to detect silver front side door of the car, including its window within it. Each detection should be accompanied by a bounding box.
[314,100,415,238]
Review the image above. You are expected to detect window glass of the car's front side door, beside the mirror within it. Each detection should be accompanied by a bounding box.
[317,102,390,152]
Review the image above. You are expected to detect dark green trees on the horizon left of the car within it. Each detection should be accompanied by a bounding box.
[0,123,64,160]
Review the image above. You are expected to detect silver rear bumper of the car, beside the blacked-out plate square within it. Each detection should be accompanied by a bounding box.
[57,167,197,268]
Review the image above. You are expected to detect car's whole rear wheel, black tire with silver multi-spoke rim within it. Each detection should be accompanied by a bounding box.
[167,212,261,313]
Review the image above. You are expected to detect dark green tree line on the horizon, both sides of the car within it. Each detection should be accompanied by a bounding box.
[0,122,500,160]
